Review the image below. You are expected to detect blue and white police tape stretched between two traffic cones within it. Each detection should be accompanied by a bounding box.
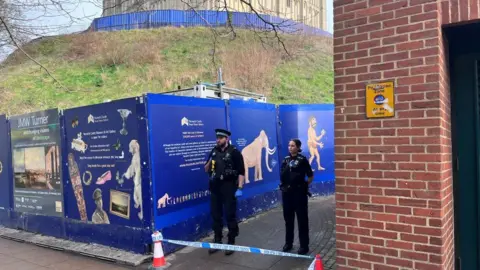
[152,232,315,260]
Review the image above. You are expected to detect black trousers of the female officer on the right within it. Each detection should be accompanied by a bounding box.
[282,188,309,248]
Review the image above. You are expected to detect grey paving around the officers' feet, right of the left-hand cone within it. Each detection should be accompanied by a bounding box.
[167,196,336,270]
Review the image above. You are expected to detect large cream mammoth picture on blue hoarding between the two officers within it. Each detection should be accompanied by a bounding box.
[242,130,277,183]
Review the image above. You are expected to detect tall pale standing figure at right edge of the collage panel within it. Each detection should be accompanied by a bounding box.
[123,140,143,220]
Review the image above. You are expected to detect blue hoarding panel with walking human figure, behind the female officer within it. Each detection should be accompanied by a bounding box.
[279,104,335,182]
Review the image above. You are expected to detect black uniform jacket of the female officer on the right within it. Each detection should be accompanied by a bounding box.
[280,154,313,186]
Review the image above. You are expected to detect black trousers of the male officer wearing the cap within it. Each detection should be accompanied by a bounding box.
[210,180,239,241]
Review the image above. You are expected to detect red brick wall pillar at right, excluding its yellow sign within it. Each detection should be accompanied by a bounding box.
[334,0,454,270]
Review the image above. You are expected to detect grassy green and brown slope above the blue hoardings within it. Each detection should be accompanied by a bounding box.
[0,28,333,114]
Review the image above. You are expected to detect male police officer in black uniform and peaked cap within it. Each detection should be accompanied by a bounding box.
[205,129,245,255]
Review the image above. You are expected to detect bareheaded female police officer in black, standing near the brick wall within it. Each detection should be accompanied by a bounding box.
[280,139,313,255]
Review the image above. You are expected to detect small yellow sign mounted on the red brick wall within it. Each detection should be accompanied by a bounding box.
[365,81,395,118]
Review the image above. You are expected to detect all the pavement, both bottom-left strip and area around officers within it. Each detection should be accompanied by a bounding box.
[0,196,336,270]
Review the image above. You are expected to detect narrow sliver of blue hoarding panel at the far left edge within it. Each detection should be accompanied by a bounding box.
[0,115,12,210]
